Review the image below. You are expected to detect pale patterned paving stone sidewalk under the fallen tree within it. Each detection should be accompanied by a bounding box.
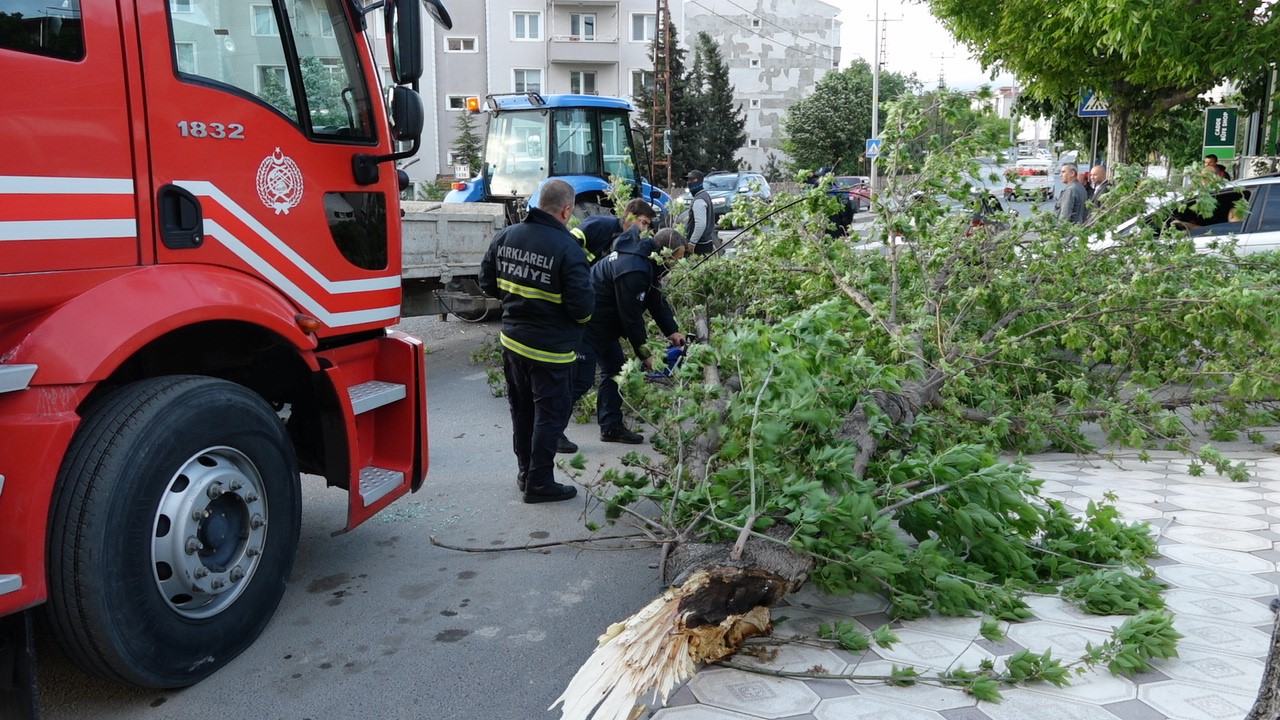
[650,448,1280,720]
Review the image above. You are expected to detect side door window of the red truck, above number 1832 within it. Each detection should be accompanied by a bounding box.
[169,0,375,142]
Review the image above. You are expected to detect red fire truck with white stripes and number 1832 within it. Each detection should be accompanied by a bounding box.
[0,0,451,717]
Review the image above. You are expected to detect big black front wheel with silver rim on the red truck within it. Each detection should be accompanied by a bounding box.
[46,375,302,688]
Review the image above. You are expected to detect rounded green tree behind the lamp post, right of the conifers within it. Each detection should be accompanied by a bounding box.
[782,59,919,174]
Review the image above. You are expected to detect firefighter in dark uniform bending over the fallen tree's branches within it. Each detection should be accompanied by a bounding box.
[573,224,690,445]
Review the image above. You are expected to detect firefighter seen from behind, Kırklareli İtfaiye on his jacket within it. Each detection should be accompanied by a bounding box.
[480,179,595,502]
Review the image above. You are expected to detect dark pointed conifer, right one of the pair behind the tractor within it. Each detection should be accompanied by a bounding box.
[677,32,746,173]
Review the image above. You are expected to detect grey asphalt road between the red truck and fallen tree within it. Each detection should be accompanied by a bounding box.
[37,318,660,720]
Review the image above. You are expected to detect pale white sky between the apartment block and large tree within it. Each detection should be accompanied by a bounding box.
[824,0,1011,90]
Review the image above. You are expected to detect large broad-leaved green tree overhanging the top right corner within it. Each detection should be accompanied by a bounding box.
[927,0,1280,164]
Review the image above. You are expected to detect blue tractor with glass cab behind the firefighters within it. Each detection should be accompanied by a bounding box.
[444,92,671,223]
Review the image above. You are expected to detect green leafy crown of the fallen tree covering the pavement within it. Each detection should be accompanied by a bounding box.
[550,95,1280,717]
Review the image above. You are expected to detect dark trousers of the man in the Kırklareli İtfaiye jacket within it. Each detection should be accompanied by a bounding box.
[502,350,573,488]
